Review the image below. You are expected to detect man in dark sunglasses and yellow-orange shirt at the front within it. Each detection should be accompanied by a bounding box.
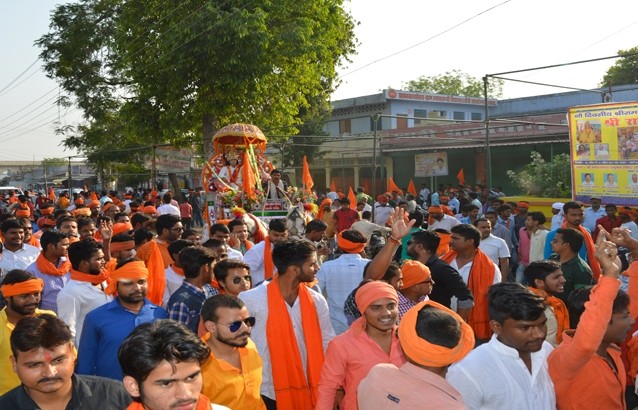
[202,296,266,410]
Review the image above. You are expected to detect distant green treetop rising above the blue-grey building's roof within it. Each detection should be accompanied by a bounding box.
[403,70,504,98]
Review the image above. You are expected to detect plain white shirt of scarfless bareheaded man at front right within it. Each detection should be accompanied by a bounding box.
[446,334,556,410]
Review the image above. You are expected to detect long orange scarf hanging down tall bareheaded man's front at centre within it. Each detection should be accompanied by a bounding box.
[266,278,324,410]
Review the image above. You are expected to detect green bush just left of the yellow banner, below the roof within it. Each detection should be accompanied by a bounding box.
[507,151,572,198]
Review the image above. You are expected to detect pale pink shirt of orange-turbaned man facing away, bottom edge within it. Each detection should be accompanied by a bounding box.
[359,363,466,410]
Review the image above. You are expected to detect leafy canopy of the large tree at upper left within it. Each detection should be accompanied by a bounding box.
[36,0,355,165]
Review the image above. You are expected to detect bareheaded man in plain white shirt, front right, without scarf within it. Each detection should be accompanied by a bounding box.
[446,282,556,410]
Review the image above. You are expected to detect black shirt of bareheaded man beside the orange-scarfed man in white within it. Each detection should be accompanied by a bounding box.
[425,255,474,308]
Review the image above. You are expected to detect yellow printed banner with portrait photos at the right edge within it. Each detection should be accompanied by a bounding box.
[568,102,638,206]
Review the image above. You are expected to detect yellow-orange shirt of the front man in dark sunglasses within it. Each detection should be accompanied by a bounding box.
[202,333,266,410]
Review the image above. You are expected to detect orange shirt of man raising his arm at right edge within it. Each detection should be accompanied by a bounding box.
[547,276,626,410]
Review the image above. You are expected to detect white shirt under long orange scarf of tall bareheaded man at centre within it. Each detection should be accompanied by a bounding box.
[239,282,335,400]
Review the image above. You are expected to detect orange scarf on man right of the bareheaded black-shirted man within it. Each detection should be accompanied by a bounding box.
[441,249,494,339]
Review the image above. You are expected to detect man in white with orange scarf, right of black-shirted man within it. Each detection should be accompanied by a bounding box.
[441,224,501,342]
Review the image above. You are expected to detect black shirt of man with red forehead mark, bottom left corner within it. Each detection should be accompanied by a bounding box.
[0,374,132,410]
